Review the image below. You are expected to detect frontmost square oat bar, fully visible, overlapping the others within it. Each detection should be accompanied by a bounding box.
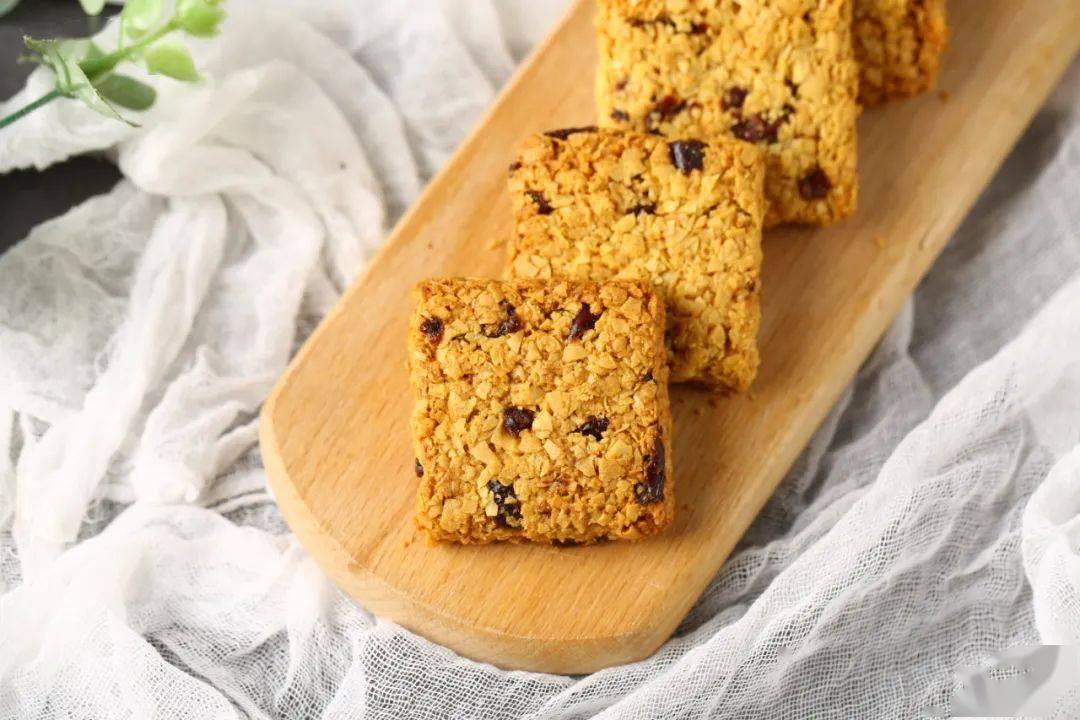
[408,279,675,544]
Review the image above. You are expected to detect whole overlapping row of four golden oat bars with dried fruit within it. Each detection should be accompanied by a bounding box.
[409,0,946,545]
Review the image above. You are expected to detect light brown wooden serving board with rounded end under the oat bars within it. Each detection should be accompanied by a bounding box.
[261,0,1080,674]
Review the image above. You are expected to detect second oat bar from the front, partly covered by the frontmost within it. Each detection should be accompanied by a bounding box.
[507,128,765,391]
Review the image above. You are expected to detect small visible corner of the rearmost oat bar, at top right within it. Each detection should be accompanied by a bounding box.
[852,0,948,105]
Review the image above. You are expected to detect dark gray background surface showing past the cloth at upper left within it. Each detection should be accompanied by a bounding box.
[0,0,120,253]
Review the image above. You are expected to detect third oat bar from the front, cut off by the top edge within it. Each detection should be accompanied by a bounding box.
[596,0,859,227]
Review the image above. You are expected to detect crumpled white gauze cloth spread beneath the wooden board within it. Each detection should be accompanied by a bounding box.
[0,0,1080,720]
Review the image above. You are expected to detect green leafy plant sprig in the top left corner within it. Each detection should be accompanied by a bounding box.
[0,0,225,127]
